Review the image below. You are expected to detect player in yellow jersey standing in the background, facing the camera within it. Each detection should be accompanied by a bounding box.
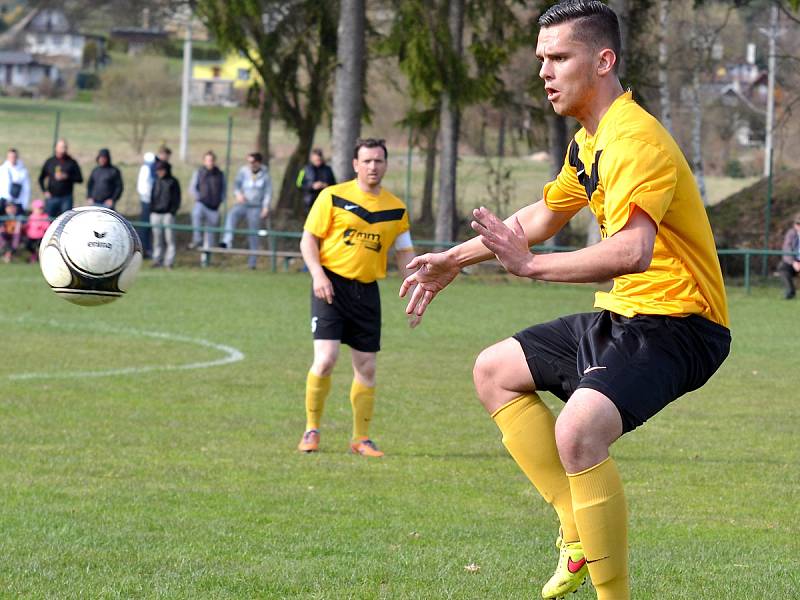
[297,138,420,457]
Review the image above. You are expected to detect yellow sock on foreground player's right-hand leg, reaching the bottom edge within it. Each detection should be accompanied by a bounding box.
[568,458,631,600]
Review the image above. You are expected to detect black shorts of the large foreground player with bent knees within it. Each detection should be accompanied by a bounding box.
[513,310,731,433]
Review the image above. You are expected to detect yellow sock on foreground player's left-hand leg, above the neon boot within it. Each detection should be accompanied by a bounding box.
[492,393,578,542]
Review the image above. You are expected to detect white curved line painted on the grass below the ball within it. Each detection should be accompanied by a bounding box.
[7,317,245,380]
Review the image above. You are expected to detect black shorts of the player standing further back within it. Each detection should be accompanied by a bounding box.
[311,269,381,352]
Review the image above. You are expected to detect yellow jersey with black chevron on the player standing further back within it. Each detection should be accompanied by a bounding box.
[304,179,409,283]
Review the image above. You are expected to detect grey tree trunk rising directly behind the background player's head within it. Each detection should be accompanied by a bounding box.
[333,0,366,181]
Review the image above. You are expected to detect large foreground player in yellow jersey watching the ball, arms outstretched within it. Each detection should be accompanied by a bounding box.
[400,1,731,600]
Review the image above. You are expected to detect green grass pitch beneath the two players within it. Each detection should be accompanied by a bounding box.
[0,264,800,600]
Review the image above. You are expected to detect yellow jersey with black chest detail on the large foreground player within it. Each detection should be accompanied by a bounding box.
[544,92,728,327]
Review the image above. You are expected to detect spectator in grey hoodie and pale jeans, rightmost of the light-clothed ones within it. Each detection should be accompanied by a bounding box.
[220,152,272,269]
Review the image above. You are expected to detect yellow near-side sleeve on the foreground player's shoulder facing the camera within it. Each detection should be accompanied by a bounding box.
[600,139,678,236]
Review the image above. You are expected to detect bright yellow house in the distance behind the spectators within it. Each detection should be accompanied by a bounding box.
[190,54,258,106]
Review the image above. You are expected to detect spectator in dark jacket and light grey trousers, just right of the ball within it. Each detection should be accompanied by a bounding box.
[150,160,181,269]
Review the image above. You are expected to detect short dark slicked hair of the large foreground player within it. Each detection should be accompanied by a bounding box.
[539,0,622,71]
